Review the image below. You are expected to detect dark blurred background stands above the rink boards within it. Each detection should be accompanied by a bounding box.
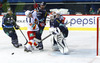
[0,0,100,14]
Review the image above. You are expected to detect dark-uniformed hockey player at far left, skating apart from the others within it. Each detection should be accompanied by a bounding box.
[2,10,22,48]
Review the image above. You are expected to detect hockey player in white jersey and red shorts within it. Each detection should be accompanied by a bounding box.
[24,11,39,52]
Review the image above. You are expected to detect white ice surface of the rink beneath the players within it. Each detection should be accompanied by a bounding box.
[0,30,100,63]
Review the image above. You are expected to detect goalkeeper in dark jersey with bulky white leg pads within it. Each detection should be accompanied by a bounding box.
[49,12,68,54]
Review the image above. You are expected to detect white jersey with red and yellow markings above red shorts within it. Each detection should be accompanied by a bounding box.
[26,17,39,31]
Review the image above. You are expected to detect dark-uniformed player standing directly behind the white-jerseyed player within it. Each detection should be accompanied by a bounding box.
[36,2,47,50]
